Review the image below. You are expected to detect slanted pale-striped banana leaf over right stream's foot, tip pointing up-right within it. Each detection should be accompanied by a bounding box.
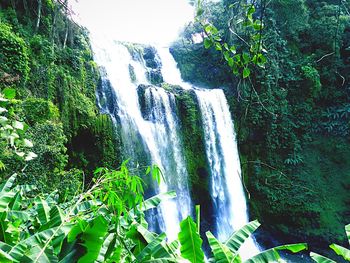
[225,220,260,254]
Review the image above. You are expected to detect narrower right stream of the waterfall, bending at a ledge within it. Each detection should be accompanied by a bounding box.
[157,48,259,259]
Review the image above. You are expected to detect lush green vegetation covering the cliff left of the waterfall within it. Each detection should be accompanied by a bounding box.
[0,0,120,194]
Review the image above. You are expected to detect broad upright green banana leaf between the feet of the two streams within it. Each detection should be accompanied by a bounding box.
[179,216,204,263]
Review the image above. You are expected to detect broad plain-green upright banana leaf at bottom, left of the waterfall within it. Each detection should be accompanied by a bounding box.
[78,216,108,263]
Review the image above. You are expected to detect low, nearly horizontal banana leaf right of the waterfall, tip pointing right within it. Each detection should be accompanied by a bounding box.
[245,243,307,263]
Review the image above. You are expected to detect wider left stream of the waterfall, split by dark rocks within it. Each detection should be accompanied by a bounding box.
[92,38,192,240]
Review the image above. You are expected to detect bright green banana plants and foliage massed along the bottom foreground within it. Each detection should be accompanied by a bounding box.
[0,169,307,263]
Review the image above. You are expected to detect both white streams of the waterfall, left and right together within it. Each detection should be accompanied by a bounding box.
[92,36,258,258]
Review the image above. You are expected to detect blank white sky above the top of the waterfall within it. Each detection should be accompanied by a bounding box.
[70,0,194,44]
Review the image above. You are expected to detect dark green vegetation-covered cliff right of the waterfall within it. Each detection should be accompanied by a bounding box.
[172,0,350,258]
